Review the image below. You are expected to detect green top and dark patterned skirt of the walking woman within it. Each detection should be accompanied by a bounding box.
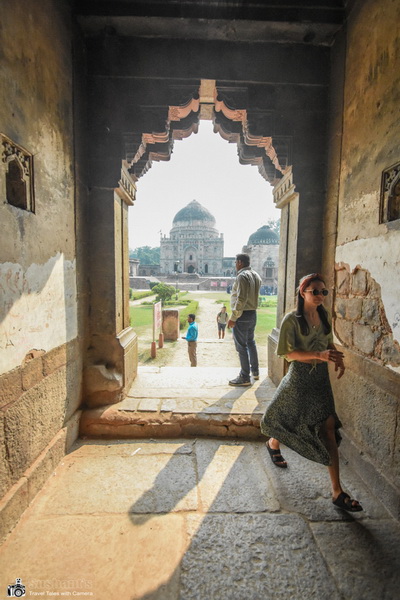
[261,312,342,465]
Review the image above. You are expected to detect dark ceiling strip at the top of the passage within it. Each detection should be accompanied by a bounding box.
[72,0,354,45]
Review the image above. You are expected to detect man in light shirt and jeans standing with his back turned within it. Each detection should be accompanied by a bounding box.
[228,254,261,386]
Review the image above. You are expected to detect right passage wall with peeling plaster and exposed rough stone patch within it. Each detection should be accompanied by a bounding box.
[324,0,400,515]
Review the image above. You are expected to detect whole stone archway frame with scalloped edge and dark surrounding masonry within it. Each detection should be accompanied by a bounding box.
[88,39,326,397]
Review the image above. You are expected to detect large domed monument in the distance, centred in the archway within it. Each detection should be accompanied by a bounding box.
[160,200,224,275]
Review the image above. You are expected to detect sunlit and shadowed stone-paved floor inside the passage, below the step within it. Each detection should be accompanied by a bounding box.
[0,439,400,600]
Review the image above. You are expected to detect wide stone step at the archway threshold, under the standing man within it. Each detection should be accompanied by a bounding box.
[80,367,275,440]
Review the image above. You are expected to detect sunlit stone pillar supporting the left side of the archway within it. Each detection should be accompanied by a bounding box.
[85,151,138,407]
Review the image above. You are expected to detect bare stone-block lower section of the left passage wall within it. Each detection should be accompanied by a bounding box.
[0,340,82,537]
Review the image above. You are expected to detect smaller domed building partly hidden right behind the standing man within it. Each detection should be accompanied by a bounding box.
[243,225,279,293]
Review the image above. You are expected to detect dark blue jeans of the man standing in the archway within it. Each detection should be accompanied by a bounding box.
[232,310,258,379]
